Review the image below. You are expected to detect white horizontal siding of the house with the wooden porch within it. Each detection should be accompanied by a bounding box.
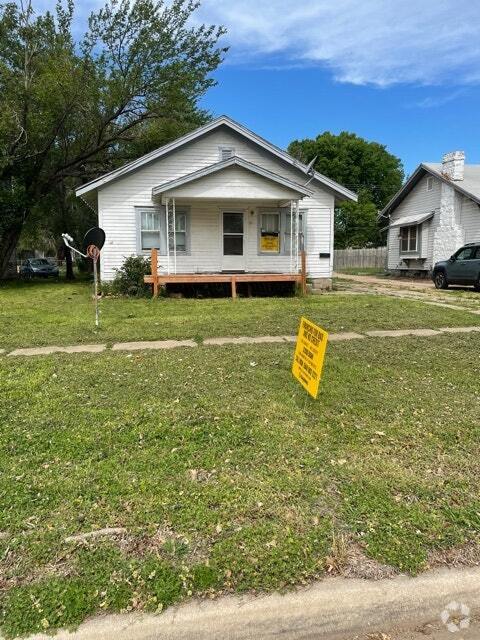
[98,127,334,280]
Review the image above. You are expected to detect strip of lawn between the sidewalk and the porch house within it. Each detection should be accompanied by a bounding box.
[0,282,480,348]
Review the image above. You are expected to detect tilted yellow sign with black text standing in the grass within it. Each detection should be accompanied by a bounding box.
[292,318,328,398]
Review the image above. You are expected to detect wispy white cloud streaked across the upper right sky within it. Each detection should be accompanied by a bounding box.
[198,0,480,86]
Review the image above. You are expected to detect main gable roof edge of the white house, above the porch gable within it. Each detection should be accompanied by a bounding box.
[75,116,357,202]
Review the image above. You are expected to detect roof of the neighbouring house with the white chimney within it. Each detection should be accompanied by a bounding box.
[380,162,480,216]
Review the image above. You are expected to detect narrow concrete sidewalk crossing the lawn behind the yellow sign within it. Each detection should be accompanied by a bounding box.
[0,325,480,357]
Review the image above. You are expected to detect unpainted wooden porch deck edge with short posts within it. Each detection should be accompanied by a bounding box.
[144,249,307,298]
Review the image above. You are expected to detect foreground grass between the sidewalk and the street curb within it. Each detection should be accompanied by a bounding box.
[0,336,480,637]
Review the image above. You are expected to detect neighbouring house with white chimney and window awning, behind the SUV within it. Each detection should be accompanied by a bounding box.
[382,151,480,273]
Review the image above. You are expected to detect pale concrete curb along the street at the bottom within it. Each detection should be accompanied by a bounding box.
[25,567,480,640]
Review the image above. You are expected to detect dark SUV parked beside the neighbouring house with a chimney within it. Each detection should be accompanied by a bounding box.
[432,242,480,291]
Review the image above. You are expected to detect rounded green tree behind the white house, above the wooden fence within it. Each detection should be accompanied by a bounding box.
[288,131,404,248]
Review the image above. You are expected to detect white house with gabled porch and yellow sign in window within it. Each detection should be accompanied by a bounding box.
[76,116,356,287]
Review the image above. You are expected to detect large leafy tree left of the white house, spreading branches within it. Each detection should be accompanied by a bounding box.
[0,0,225,276]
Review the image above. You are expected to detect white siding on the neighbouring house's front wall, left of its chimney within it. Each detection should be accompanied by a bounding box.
[387,176,441,269]
